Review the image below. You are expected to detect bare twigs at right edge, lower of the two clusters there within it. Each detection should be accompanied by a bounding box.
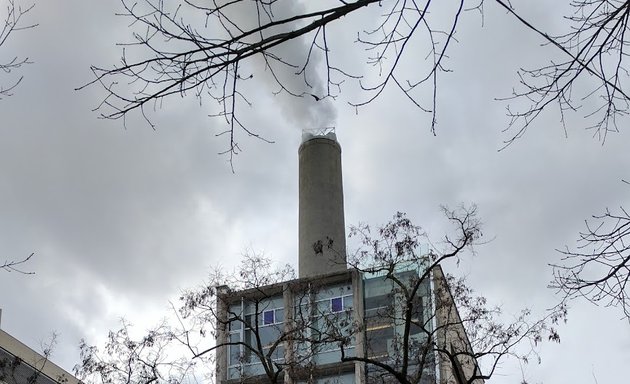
[550,207,630,319]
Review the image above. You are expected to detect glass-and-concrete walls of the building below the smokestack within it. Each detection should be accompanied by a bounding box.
[217,266,483,384]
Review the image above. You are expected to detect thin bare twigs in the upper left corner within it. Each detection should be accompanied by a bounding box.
[0,0,37,99]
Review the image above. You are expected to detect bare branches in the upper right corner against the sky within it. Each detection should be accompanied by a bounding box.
[495,0,630,146]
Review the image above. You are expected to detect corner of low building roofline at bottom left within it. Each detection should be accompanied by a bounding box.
[0,311,79,384]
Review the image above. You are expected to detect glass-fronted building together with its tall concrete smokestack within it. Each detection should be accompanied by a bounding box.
[216,131,483,384]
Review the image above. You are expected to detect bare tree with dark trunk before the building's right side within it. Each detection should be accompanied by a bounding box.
[320,207,566,384]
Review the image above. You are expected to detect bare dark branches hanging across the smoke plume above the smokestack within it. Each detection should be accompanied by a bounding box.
[79,0,483,158]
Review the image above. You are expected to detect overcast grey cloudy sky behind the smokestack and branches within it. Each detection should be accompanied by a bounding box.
[0,0,630,383]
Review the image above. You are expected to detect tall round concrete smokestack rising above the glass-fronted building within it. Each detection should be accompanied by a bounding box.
[298,129,347,277]
